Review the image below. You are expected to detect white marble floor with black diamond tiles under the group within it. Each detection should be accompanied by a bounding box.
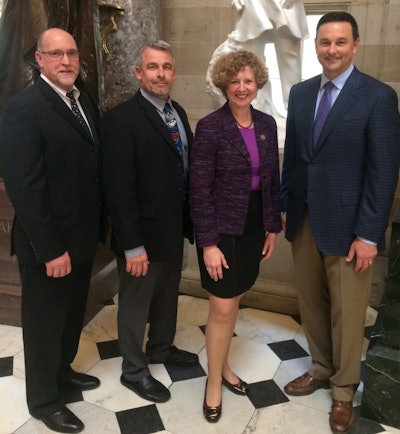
[0,295,400,434]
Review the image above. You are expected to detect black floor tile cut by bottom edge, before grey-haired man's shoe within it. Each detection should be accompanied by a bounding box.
[116,404,165,434]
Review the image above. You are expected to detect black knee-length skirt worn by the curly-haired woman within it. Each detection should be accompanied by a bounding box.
[197,192,265,298]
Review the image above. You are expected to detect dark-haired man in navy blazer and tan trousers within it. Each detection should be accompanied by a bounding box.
[281,12,400,432]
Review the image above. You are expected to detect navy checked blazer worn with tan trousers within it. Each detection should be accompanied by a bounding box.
[281,68,400,256]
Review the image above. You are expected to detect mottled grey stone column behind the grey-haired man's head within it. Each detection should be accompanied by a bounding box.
[99,0,162,111]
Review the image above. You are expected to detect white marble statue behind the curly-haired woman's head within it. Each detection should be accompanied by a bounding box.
[207,0,308,116]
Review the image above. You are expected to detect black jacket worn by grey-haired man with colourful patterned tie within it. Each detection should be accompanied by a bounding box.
[100,91,193,261]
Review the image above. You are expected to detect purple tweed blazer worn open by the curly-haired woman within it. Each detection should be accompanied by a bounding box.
[189,103,282,247]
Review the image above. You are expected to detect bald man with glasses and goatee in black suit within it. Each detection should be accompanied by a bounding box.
[0,28,102,433]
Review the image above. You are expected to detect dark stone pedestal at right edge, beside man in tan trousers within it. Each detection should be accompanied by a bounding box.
[361,206,400,428]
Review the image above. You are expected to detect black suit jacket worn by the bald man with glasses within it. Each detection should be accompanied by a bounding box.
[0,78,102,264]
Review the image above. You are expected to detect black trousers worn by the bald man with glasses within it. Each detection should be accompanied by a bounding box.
[19,262,92,418]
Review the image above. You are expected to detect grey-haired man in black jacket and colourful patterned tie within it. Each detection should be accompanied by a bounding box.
[100,41,198,402]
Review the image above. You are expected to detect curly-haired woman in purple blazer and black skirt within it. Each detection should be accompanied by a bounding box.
[190,51,281,422]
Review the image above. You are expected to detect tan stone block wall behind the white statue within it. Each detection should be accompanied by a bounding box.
[161,0,400,127]
